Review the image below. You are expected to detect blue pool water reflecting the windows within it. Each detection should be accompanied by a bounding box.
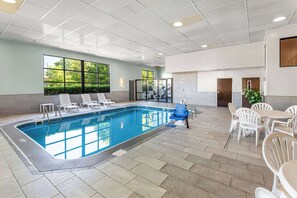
[18,107,170,159]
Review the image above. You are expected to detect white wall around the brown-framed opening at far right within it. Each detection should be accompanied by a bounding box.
[265,25,297,96]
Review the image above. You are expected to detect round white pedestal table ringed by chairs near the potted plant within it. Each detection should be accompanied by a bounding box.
[255,109,294,135]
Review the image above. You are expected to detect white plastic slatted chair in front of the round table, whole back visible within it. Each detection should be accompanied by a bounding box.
[236,108,264,146]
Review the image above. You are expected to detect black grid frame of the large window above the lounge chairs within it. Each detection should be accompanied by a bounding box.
[43,54,111,96]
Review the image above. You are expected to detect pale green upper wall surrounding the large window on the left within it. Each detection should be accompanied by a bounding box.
[0,39,158,95]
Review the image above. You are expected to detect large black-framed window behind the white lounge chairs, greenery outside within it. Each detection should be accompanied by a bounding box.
[43,55,110,95]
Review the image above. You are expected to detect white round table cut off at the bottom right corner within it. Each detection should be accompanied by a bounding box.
[279,160,297,197]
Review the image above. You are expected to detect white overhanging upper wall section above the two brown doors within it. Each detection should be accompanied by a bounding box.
[165,42,264,73]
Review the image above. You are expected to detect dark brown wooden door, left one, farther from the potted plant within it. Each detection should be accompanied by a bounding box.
[217,78,232,107]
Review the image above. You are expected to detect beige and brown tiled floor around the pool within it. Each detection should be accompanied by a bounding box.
[0,103,273,198]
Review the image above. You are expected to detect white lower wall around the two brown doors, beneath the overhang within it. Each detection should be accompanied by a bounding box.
[197,68,265,92]
